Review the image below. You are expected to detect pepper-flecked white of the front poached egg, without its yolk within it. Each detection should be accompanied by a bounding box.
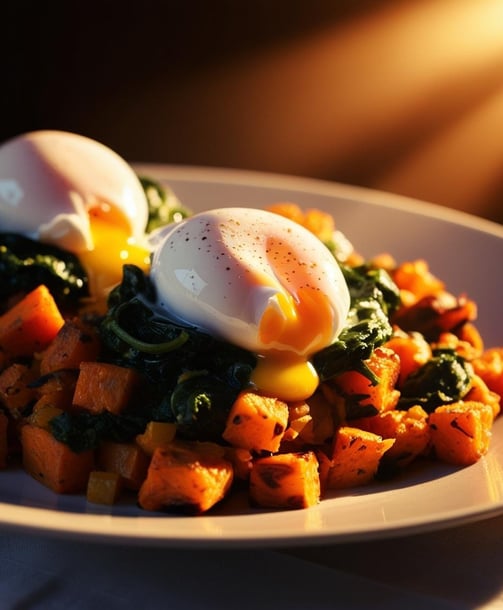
[151,208,349,356]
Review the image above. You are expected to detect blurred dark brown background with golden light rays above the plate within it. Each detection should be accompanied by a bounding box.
[0,0,503,222]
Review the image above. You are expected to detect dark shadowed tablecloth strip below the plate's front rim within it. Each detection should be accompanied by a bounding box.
[0,510,503,610]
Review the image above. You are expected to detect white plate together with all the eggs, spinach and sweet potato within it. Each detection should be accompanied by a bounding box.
[0,132,503,547]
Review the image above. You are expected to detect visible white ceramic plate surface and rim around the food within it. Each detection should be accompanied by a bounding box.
[0,166,503,547]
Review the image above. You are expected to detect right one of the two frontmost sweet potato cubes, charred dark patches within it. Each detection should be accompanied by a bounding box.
[250,451,320,509]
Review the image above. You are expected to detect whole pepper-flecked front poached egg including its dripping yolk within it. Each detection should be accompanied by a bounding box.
[151,208,349,400]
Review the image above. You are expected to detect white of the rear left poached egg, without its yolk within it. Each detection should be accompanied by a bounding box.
[0,130,148,253]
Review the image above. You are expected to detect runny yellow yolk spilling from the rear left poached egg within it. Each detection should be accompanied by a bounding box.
[79,202,150,302]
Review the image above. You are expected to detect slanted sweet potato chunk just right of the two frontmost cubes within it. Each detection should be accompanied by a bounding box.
[328,426,395,489]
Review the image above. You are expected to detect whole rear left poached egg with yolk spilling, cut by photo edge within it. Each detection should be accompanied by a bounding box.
[0,130,150,299]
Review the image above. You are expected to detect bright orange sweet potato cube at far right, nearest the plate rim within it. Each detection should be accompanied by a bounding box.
[429,401,494,466]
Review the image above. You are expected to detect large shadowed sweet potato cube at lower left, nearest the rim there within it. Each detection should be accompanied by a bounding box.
[21,424,94,494]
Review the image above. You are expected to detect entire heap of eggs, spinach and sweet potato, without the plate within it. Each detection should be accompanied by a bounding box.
[0,131,503,514]
